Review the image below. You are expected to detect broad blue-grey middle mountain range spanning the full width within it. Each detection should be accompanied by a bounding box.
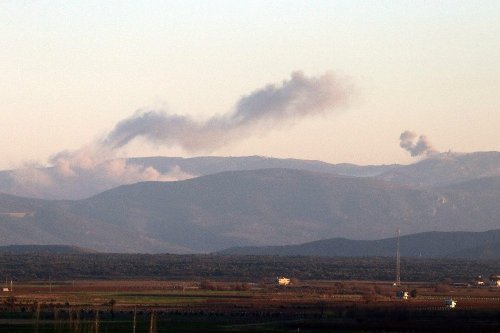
[0,169,500,253]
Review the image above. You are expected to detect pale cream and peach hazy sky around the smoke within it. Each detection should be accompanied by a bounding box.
[0,0,500,169]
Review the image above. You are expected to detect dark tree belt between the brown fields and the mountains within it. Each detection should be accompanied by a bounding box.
[0,253,500,282]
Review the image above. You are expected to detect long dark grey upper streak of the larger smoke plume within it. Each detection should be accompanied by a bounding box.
[102,72,351,152]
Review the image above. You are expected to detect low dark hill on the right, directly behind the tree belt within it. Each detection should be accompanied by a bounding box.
[218,229,500,259]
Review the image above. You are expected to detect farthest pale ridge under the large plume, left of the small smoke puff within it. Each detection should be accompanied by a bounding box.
[0,156,396,200]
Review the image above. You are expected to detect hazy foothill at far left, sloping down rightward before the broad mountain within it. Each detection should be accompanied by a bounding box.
[0,194,190,253]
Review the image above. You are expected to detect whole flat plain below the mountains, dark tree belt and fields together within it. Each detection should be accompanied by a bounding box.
[0,254,500,333]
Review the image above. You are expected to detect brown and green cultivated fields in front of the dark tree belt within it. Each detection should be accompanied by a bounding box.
[0,280,500,332]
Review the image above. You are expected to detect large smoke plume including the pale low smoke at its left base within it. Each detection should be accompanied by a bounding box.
[7,72,352,198]
